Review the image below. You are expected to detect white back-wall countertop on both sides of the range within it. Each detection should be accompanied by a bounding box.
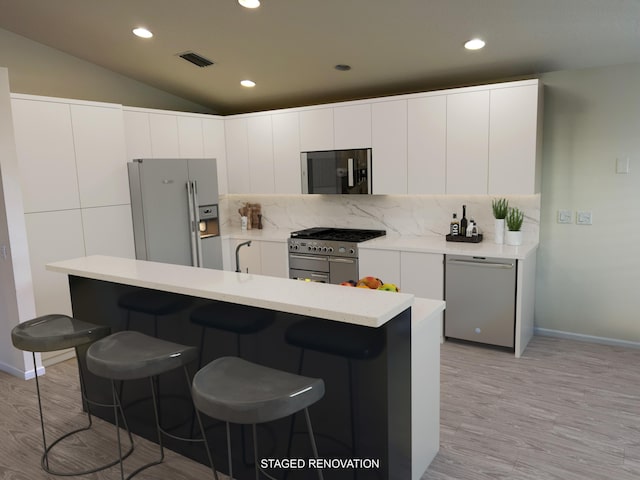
[222,229,538,260]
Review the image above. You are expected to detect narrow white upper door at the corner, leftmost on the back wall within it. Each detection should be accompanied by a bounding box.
[224,118,251,193]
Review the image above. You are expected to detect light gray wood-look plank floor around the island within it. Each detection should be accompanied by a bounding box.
[0,337,640,480]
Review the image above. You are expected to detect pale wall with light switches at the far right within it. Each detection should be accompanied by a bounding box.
[535,64,640,342]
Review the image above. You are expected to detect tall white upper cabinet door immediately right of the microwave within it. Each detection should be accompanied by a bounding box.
[371,100,407,194]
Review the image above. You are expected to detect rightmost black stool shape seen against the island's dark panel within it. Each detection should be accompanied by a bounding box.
[285,319,385,464]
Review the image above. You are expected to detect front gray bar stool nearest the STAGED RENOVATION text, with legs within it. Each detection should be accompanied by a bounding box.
[192,357,324,480]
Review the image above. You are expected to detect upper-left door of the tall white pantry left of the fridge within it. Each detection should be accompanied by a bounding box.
[11,99,80,213]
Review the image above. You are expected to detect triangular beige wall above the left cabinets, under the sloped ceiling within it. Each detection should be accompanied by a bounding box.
[0,28,215,113]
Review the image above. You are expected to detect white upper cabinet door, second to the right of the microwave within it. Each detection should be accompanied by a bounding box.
[407,95,447,195]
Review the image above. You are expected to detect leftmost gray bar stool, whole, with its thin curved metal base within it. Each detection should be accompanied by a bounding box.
[11,314,133,476]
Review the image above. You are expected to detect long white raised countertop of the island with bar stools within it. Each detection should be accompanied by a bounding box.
[47,255,428,327]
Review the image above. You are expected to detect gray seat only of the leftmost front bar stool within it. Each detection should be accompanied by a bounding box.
[11,314,111,352]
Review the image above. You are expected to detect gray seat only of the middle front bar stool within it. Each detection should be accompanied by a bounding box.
[87,330,198,380]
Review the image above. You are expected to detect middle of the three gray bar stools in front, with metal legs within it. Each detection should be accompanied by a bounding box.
[87,330,218,480]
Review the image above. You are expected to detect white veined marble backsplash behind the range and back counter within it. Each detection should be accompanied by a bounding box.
[220,194,540,242]
